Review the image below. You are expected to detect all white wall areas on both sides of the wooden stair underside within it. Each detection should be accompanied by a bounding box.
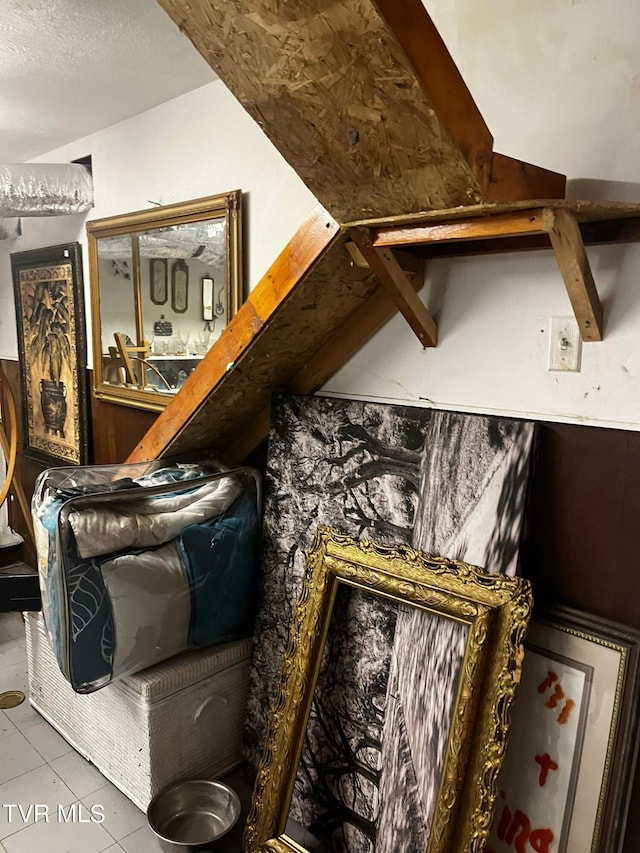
[0,0,640,430]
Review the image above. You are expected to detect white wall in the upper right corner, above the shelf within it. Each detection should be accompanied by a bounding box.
[423,0,640,186]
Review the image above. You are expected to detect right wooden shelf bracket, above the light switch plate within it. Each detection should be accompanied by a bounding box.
[542,208,602,341]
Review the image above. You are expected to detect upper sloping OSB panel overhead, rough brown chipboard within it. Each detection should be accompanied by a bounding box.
[159,0,490,223]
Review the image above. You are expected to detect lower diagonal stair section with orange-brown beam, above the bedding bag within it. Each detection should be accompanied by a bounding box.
[128,208,422,463]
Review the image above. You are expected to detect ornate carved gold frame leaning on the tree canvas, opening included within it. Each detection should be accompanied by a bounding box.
[244,527,532,853]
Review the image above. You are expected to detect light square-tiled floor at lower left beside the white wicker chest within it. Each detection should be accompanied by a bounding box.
[0,613,168,853]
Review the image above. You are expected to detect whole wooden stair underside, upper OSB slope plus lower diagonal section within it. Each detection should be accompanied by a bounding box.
[129,0,565,462]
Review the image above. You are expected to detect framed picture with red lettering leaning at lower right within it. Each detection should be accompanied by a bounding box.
[486,608,640,853]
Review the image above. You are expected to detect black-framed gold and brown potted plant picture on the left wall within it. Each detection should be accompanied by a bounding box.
[11,243,88,465]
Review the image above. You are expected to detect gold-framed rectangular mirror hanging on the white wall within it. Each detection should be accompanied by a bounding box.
[87,190,242,411]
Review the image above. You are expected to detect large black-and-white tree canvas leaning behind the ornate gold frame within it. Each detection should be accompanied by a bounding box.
[245,395,533,853]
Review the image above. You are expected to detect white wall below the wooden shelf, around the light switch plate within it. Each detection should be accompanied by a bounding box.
[324,245,640,429]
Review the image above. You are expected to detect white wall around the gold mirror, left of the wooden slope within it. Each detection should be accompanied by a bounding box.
[0,80,317,364]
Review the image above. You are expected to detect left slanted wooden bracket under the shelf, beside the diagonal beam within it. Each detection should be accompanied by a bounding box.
[350,228,438,347]
